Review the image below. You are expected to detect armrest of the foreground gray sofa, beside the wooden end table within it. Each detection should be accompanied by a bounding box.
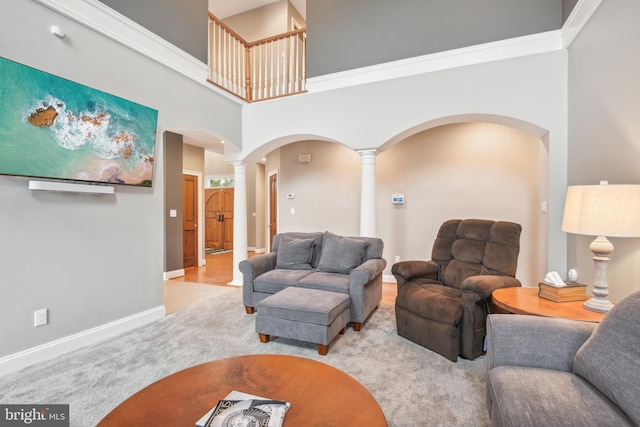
[486,314,597,372]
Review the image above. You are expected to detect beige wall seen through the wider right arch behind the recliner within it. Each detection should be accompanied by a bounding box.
[376,123,547,286]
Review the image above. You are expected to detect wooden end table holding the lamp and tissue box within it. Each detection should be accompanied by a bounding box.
[491,287,605,322]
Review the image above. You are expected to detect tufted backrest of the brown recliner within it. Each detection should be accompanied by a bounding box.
[431,219,522,289]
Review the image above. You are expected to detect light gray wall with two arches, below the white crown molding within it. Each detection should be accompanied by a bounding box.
[242,50,567,283]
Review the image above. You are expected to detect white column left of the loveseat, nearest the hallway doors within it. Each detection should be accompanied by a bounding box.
[229,162,247,286]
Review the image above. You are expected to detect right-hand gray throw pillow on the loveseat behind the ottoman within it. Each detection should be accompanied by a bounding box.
[318,231,369,274]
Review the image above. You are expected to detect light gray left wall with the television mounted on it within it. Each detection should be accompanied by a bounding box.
[0,1,241,362]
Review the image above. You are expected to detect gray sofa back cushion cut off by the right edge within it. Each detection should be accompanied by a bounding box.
[573,292,640,425]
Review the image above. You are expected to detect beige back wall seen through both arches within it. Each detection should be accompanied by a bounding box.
[268,123,548,286]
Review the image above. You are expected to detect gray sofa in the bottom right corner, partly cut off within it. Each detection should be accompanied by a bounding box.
[486,292,640,427]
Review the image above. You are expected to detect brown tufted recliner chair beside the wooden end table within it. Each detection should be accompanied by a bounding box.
[391,219,522,362]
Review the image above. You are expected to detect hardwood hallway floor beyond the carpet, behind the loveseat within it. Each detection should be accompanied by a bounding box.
[164,252,396,314]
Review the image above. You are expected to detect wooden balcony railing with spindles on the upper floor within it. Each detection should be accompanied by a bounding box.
[209,13,307,102]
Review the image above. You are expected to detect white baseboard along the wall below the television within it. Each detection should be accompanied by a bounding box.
[0,305,166,376]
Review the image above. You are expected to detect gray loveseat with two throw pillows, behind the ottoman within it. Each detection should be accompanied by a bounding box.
[239,231,387,331]
